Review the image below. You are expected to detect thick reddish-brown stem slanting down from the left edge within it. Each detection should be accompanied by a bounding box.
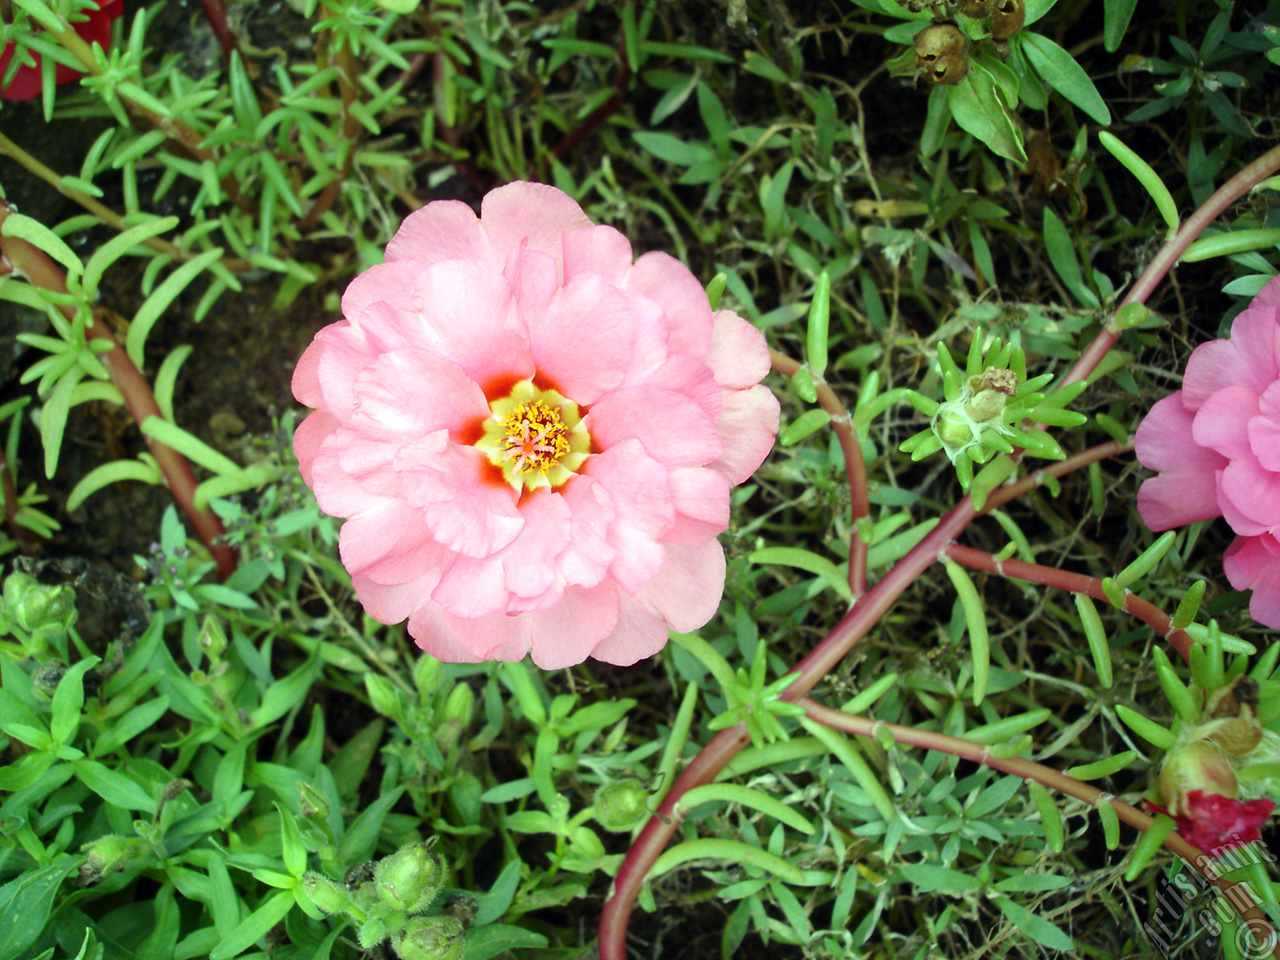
[0,201,236,580]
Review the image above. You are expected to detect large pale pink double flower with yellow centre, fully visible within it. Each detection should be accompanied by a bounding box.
[293,183,778,668]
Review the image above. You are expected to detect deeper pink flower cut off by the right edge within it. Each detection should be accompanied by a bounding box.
[1134,278,1280,627]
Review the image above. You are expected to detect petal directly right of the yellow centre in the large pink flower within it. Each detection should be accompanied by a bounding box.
[588,387,721,468]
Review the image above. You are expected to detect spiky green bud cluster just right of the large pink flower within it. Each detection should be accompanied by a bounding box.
[900,330,1087,490]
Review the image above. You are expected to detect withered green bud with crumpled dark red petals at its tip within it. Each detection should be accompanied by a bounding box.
[1147,676,1280,856]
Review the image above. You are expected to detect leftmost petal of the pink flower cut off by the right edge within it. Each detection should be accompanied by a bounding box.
[1134,392,1228,530]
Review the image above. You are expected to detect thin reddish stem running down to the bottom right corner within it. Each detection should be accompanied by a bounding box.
[798,699,1280,957]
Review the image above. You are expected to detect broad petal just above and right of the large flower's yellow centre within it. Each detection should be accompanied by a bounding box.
[529,274,636,406]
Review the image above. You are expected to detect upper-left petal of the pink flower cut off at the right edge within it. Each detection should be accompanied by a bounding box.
[1183,306,1280,410]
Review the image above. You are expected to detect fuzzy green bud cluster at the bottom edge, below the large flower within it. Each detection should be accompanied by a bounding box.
[302,837,466,960]
